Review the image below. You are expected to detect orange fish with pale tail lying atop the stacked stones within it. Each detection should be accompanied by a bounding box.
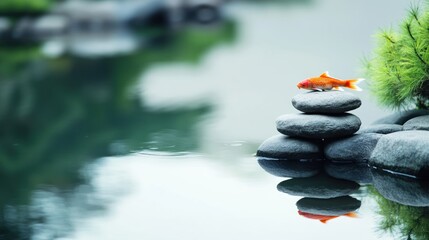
[296,72,364,91]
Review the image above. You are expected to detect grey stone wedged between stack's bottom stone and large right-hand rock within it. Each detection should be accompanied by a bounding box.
[324,133,383,162]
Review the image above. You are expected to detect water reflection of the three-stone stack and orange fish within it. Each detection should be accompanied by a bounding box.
[258,157,361,223]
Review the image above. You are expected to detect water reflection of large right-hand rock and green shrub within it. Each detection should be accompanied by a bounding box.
[369,170,429,240]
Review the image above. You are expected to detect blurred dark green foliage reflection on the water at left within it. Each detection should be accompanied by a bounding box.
[0,19,235,239]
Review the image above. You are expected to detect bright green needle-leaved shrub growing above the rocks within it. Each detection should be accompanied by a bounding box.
[366,1,429,109]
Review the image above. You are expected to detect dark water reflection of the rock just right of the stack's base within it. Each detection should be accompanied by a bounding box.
[325,161,372,185]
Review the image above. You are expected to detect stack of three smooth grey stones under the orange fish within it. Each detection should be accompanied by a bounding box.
[257,91,362,160]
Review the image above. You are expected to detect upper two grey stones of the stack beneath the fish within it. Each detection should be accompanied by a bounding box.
[276,91,361,139]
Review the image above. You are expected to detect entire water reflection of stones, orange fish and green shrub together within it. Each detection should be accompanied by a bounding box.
[258,158,429,240]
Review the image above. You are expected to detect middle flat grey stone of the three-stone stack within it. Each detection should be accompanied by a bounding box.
[276,113,361,139]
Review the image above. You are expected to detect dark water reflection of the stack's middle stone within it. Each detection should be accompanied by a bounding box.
[277,174,360,198]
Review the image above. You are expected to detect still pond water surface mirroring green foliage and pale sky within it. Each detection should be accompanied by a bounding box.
[0,0,429,240]
